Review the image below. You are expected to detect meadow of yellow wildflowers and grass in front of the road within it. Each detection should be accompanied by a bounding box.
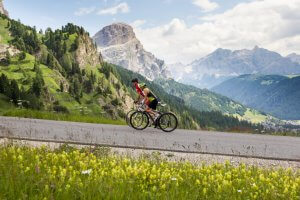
[0,145,300,200]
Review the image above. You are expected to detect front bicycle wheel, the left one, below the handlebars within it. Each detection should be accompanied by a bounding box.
[130,111,149,130]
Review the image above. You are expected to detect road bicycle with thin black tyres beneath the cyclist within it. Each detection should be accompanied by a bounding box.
[128,103,178,132]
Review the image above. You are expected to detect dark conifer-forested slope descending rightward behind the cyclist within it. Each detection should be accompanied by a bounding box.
[112,66,262,131]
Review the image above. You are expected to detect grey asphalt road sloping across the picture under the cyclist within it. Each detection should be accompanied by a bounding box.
[0,117,300,161]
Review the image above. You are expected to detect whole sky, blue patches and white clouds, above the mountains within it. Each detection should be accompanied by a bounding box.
[4,0,300,64]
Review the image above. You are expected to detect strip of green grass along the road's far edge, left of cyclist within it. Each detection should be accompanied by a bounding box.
[3,109,126,125]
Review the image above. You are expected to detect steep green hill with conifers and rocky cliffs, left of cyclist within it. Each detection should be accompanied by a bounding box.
[0,15,133,119]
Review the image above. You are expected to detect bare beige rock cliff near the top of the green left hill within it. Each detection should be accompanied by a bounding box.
[75,34,102,68]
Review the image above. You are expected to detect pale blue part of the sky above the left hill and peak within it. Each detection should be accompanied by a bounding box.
[4,0,246,35]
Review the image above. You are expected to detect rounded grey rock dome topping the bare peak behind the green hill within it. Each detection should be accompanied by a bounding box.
[94,23,136,47]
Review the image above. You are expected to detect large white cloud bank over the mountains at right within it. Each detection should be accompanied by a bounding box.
[134,0,300,63]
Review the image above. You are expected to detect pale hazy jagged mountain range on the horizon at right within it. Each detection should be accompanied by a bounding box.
[178,46,300,88]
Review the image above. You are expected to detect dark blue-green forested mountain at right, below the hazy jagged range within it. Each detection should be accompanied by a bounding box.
[212,74,300,120]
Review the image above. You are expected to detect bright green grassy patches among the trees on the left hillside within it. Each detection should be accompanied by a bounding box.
[0,21,124,124]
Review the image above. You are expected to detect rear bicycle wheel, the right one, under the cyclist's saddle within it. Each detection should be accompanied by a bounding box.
[158,113,178,132]
